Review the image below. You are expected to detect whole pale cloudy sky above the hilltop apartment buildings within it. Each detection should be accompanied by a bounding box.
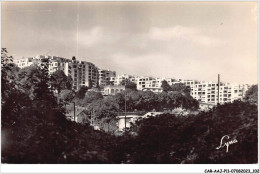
[2,2,258,84]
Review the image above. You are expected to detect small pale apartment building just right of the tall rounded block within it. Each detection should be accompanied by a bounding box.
[98,69,116,87]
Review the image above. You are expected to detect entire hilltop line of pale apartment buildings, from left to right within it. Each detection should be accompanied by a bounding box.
[15,55,250,105]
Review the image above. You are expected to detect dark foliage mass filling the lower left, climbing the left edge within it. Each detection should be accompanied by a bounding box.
[1,48,115,163]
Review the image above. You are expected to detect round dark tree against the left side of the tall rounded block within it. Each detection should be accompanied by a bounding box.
[50,70,73,94]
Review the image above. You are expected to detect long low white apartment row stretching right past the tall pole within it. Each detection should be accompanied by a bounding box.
[110,74,250,105]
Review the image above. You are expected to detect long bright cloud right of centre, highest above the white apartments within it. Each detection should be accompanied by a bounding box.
[148,25,221,46]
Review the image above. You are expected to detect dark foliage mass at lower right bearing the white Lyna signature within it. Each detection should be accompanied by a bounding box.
[114,102,258,164]
